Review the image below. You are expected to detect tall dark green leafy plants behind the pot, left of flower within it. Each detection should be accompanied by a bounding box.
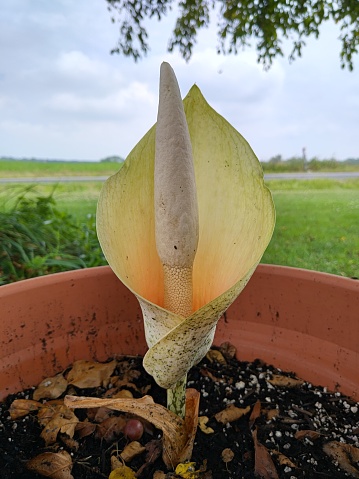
[0,188,106,285]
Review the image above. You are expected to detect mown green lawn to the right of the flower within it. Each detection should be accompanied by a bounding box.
[262,180,359,277]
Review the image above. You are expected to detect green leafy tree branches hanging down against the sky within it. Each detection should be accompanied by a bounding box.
[106,0,359,70]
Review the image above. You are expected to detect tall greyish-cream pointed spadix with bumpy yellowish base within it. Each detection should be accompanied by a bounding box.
[154,63,198,317]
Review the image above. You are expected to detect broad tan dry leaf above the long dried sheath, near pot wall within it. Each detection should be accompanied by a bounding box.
[67,360,117,388]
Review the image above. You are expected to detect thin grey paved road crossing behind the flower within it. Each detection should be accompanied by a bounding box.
[0,171,359,183]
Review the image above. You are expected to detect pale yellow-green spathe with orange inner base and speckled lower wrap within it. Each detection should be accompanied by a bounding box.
[97,64,275,389]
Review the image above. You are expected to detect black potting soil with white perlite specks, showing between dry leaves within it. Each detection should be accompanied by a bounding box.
[0,350,359,479]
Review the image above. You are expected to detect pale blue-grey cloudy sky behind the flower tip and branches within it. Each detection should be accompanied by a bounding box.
[0,0,359,160]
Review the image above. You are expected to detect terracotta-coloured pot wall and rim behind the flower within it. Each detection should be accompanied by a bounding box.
[0,265,359,400]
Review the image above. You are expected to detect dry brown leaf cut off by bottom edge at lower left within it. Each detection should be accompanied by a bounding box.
[26,451,74,479]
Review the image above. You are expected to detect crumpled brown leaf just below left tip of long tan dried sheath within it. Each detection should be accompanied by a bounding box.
[38,405,79,446]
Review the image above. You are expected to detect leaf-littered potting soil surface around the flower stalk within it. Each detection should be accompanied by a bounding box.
[0,344,359,479]
